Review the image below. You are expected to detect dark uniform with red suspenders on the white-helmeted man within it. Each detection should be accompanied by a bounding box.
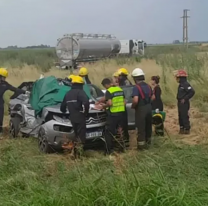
[132,82,152,149]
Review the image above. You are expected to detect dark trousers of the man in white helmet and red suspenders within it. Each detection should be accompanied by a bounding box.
[135,104,152,145]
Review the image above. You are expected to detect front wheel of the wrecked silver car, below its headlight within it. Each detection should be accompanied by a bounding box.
[38,128,52,153]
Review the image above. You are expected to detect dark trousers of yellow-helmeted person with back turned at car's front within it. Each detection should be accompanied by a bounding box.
[72,119,86,144]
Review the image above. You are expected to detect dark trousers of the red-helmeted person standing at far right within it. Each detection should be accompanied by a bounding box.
[178,102,191,130]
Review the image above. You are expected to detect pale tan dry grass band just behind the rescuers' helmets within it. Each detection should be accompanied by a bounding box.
[8,59,161,86]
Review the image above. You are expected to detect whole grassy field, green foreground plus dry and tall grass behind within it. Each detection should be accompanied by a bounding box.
[0,46,208,206]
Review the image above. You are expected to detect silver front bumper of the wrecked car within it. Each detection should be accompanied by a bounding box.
[41,120,105,148]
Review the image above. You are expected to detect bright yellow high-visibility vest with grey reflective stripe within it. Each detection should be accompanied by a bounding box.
[107,86,125,113]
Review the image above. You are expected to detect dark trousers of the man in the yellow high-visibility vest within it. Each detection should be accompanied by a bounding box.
[105,113,127,152]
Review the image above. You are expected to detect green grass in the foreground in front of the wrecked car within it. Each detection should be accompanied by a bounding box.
[0,140,208,206]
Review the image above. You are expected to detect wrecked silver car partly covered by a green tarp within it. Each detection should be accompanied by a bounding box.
[9,76,106,153]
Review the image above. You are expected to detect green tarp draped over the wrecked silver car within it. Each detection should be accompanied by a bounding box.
[30,76,90,115]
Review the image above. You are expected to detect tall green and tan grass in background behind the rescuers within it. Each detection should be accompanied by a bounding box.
[0,46,208,106]
